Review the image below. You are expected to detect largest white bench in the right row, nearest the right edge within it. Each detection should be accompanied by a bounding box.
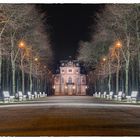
[126,91,138,103]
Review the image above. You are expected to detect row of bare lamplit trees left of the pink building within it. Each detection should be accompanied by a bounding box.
[0,4,52,96]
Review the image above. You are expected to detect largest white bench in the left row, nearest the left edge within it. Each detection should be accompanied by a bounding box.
[3,91,15,103]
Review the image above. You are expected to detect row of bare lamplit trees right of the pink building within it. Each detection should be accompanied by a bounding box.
[78,4,140,95]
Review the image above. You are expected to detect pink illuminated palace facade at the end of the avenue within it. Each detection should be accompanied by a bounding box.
[53,60,87,96]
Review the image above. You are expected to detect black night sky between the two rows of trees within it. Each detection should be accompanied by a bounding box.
[37,4,103,62]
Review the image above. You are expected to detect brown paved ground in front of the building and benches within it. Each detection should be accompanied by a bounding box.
[0,96,140,136]
